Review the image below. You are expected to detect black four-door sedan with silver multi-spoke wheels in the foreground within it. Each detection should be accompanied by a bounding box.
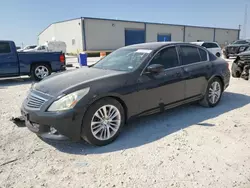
[21,42,230,146]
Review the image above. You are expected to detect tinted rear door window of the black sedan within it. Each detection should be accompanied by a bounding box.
[180,46,200,65]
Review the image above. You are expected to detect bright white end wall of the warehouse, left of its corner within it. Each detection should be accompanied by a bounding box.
[39,19,83,53]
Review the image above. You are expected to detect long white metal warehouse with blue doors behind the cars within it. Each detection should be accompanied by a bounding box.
[38,17,240,53]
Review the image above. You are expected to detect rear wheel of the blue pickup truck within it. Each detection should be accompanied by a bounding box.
[31,63,52,81]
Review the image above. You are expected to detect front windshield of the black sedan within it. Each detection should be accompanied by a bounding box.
[93,48,152,72]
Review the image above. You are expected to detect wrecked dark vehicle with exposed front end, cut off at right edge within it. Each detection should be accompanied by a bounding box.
[231,47,250,80]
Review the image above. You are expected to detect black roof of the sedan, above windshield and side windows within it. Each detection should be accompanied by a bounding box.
[123,41,200,50]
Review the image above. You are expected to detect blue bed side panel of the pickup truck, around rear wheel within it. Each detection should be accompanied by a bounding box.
[18,52,62,75]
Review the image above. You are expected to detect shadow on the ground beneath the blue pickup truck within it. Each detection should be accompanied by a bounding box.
[0,77,34,89]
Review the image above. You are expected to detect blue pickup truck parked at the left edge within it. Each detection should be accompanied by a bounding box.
[0,40,66,81]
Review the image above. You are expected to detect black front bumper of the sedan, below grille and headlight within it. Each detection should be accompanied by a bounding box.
[21,102,82,141]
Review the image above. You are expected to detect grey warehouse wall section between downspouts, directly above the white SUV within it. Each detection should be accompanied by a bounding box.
[185,26,214,42]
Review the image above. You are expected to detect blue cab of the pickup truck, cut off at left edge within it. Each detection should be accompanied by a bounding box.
[0,41,19,76]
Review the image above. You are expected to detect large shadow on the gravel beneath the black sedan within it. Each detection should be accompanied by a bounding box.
[46,92,250,155]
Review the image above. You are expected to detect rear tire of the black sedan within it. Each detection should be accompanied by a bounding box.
[200,77,223,107]
